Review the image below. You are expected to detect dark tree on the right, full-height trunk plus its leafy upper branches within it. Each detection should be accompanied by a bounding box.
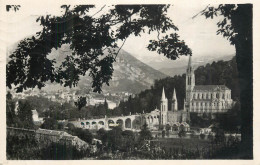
[201,4,253,158]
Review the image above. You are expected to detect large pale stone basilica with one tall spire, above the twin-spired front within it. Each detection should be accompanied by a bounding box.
[185,56,234,114]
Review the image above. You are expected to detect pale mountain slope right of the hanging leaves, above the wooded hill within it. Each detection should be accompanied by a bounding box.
[100,50,167,93]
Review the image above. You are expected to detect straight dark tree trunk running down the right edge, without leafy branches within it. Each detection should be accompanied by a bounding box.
[233,4,253,159]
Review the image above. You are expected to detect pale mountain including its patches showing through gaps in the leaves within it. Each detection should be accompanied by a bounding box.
[35,45,167,93]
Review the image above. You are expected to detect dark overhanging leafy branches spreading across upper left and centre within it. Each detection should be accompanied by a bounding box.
[6,5,191,92]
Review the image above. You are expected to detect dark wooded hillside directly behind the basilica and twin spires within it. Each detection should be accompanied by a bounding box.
[115,58,239,115]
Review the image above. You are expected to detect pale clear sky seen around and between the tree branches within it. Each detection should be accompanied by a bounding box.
[3,3,235,62]
